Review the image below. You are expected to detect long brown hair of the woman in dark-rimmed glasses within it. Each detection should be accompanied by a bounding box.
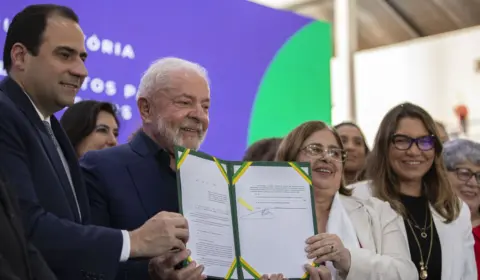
[367,103,461,223]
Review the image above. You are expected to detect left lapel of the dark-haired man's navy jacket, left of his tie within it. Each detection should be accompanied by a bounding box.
[0,77,80,221]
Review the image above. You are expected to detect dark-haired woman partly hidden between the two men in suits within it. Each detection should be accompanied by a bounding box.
[60,100,120,158]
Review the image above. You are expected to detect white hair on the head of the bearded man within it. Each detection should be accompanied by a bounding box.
[137,57,209,100]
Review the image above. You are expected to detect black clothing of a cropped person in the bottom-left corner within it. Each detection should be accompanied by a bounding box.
[0,173,56,280]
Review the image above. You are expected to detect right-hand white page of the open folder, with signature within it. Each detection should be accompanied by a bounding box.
[234,166,315,279]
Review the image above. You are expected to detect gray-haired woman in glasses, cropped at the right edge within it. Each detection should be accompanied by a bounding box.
[443,139,480,279]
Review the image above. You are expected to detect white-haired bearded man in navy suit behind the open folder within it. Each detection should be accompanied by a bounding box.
[80,58,210,280]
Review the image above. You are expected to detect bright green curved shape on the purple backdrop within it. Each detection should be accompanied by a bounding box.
[248,21,332,145]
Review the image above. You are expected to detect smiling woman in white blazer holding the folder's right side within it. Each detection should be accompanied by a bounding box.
[276,121,418,280]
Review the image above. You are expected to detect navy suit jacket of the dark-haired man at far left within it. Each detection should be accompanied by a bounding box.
[0,77,123,280]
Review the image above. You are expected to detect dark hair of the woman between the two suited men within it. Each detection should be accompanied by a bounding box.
[60,100,120,152]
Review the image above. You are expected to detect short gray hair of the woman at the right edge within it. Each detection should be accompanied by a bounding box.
[443,139,480,170]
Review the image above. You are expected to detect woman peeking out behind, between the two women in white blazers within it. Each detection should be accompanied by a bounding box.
[335,122,370,185]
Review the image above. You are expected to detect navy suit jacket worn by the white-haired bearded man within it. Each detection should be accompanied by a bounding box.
[80,131,178,280]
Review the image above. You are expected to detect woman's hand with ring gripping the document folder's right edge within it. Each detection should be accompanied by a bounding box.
[305,233,351,274]
